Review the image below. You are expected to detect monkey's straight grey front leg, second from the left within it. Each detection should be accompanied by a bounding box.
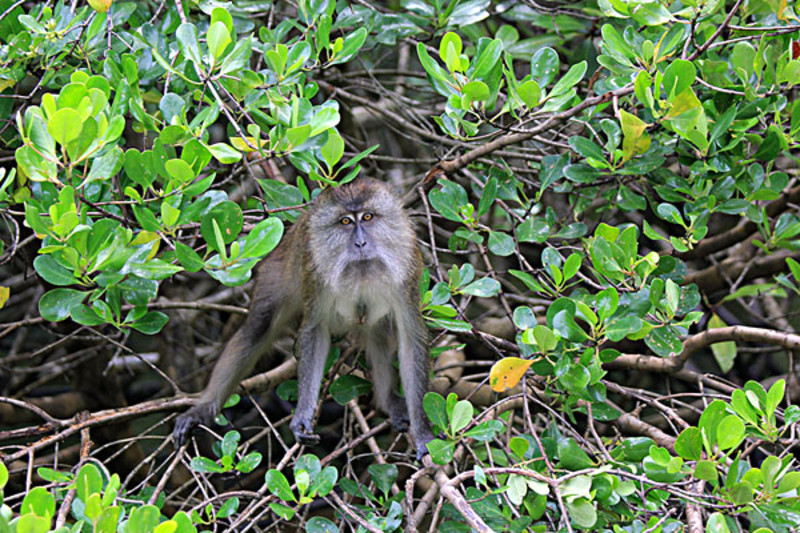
[290,322,331,444]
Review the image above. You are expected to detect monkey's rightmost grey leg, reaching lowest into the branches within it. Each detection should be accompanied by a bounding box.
[397,311,433,460]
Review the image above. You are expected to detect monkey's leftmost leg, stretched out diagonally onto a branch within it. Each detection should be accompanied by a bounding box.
[172,299,282,446]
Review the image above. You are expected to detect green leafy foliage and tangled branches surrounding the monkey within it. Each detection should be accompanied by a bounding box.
[0,0,800,533]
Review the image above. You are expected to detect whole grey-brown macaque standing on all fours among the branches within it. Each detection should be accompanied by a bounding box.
[174,178,432,458]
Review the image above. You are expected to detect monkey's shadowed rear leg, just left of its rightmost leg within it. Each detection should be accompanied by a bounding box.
[364,321,408,431]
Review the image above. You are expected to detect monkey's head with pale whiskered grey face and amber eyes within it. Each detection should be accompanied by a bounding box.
[308,178,416,286]
